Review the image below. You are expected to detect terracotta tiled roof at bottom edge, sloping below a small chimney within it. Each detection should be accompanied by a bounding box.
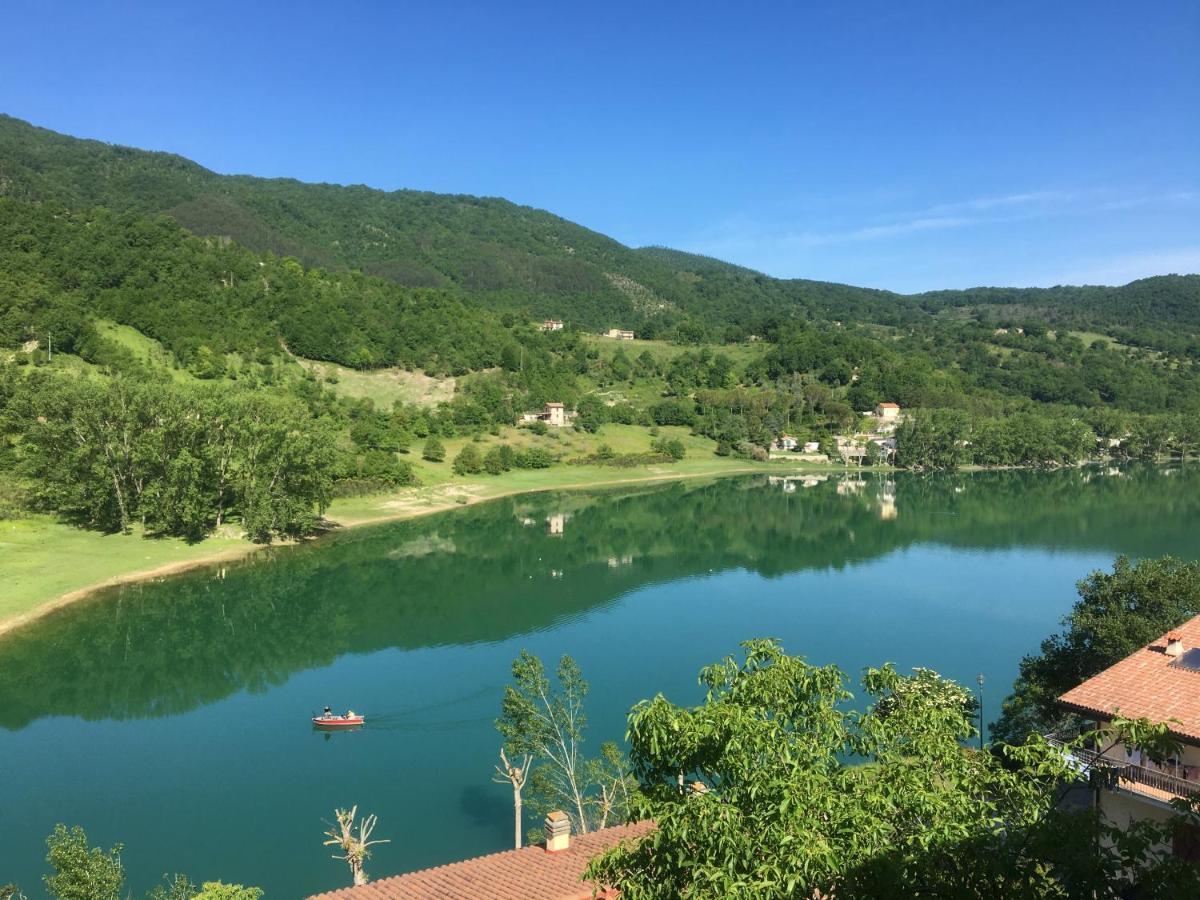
[310,822,653,900]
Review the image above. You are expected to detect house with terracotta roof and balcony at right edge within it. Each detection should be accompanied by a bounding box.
[1058,616,1200,860]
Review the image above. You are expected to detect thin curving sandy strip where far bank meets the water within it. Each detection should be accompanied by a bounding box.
[0,462,835,640]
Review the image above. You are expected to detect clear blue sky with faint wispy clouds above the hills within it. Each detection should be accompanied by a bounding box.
[0,0,1200,290]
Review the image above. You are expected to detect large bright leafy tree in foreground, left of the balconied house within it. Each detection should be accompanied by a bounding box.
[588,641,1200,900]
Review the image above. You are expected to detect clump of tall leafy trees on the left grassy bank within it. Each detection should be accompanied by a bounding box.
[0,374,334,540]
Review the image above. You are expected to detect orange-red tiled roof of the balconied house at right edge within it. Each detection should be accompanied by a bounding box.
[1058,616,1200,743]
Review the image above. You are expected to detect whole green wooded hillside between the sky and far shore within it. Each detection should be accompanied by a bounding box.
[0,116,1200,539]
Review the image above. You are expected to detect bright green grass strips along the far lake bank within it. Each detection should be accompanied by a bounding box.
[0,455,840,635]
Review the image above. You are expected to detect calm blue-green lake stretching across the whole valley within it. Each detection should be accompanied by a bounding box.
[0,467,1200,896]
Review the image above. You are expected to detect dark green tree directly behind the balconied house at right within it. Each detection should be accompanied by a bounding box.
[992,556,1200,743]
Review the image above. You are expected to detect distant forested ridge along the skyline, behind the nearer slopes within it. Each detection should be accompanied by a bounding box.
[0,115,1200,346]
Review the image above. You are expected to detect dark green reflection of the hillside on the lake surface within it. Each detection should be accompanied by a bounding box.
[0,460,1200,728]
